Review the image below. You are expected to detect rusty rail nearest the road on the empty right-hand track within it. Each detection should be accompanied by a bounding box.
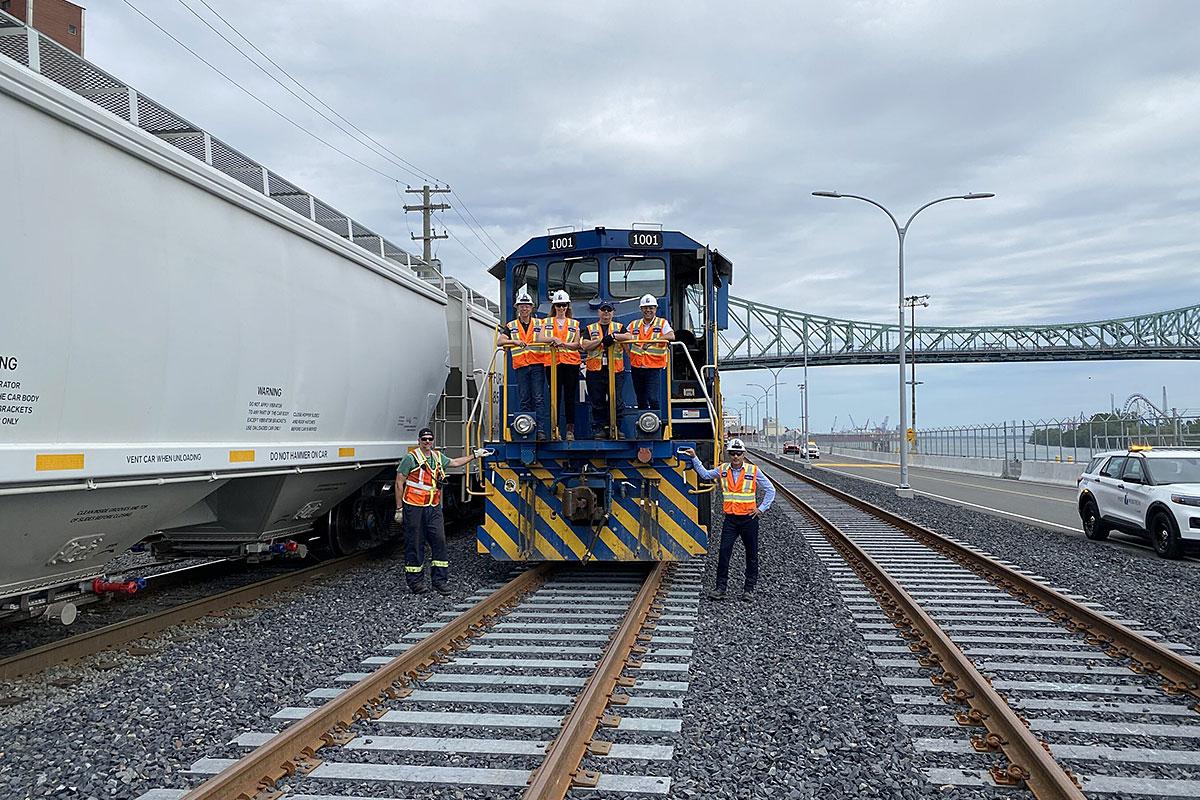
[767,458,1200,710]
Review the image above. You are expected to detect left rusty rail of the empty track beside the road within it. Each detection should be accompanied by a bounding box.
[776,460,1085,800]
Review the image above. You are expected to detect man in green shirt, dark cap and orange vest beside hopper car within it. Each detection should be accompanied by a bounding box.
[396,428,487,595]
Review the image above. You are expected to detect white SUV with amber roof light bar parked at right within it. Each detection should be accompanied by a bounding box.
[1079,446,1200,559]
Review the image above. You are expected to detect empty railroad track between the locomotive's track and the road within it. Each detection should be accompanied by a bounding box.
[757,453,1200,798]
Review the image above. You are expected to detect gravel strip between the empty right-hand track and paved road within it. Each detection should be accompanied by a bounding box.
[812,469,1200,651]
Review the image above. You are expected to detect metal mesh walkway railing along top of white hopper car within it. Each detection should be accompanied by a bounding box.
[0,11,500,317]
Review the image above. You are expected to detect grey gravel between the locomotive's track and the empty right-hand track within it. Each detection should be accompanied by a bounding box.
[629,506,1008,800]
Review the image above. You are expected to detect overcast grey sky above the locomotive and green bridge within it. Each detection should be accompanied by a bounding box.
[85,0,1200,431]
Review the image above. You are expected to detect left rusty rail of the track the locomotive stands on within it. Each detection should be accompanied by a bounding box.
[182,564,553,800]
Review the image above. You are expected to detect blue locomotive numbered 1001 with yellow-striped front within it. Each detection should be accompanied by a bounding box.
[470,228,733,561]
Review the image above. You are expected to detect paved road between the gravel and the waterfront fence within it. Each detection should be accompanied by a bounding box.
[777,453,1081,533]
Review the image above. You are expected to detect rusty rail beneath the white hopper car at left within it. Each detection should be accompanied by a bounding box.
[0,551,371,680]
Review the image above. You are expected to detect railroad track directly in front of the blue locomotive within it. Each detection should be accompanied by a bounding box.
[140,563,703,800]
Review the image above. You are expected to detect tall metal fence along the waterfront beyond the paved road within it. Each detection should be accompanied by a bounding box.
[814,413,1200,463]
